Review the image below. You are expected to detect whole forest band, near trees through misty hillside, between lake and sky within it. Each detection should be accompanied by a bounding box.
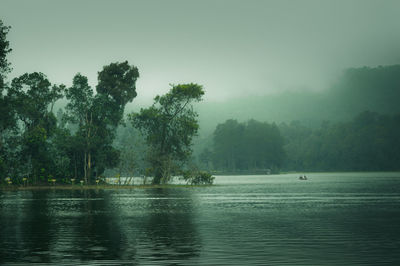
[0,20,400,187]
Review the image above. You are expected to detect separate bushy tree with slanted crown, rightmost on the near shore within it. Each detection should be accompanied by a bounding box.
[130,83,204,184]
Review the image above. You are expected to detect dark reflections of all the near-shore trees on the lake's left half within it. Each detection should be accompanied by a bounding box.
[0,189,200,263]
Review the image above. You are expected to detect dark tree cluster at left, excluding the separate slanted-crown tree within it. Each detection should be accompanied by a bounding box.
[0,20,139,183]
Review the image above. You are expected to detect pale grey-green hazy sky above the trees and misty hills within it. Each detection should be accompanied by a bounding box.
[0,0,400,104]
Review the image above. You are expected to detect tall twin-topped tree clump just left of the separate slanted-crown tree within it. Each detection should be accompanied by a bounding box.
[65,61,139,183]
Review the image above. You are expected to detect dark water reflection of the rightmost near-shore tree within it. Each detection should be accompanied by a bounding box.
[143,189,201,261]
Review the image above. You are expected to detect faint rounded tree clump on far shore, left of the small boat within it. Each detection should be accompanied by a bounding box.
[208,119,285,172]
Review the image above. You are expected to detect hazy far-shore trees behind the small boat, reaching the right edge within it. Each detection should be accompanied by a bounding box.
[280,111,400,171]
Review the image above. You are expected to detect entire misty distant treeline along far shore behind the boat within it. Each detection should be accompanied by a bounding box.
[199,111,400,173]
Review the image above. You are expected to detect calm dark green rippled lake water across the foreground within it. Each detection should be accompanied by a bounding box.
[0,173,400,265]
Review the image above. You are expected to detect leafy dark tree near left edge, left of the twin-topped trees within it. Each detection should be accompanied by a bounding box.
[8,72,62,181]
